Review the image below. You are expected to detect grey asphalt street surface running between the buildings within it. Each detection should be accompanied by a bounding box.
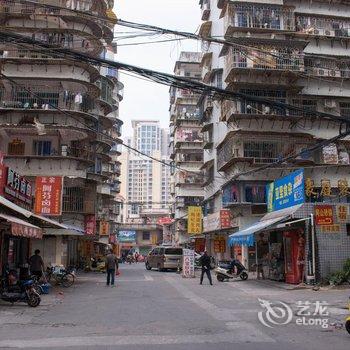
[0,264,350,350]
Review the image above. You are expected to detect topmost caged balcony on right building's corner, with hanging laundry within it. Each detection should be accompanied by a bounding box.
[224,3,295,39]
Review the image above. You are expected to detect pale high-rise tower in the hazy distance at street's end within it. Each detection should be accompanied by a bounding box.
[121,120,170,222]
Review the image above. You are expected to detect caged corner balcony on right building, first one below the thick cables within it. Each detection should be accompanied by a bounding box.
[217,132,313,171]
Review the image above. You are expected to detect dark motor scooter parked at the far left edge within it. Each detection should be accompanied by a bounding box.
[0,271,41,307]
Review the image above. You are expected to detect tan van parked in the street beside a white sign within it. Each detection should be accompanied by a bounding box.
[145,247,183,271]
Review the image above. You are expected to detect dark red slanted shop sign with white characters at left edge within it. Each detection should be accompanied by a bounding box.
[0,164,33,209]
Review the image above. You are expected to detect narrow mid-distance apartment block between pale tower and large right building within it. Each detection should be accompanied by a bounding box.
[170,52,204,245]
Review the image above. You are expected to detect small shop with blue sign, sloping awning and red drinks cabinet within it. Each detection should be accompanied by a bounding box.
[229,170,308,284]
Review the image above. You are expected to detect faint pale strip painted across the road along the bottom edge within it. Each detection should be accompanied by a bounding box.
[0,325,269,349]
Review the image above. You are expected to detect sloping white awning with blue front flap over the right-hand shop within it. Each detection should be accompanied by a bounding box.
[228,205,301,247]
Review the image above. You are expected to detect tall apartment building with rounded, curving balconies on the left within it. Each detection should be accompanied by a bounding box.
[0,0,123,265]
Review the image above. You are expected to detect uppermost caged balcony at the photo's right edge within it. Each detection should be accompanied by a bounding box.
[295,15,350,39]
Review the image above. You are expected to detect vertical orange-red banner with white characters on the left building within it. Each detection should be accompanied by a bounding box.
[34,176,63,216]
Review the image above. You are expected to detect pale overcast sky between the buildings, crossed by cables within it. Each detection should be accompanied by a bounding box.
[115,0,201,138]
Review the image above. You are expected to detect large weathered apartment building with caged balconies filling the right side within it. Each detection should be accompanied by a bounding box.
[200,0,350,277]
